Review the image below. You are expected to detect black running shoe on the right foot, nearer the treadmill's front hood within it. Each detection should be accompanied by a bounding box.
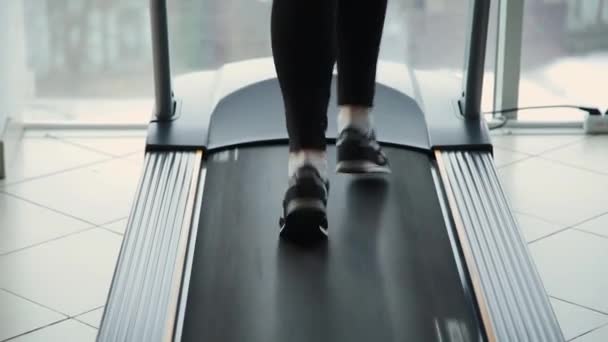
[336,127,391,173]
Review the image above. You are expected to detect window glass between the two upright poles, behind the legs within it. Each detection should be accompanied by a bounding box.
[169,0,480,72]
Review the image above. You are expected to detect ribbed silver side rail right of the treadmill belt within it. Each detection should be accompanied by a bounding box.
[435,150,565,342]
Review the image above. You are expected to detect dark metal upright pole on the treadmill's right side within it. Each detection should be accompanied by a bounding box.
[464,0,490,120]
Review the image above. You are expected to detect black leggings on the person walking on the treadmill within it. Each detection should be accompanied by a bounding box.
[271,0,387,151]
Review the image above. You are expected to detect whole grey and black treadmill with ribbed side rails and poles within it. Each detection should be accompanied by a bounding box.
[97,0,564,342]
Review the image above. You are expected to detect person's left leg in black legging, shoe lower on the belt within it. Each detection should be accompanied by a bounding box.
[271,0,336,240]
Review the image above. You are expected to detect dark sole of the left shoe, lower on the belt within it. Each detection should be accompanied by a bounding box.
[279,200,327,243]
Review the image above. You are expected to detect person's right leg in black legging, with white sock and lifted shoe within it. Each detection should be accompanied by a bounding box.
[337,0,389,173]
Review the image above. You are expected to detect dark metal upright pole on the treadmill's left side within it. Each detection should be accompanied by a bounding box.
[150,0,174,120]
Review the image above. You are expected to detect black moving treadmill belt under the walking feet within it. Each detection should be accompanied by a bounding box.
[182,146,483,342]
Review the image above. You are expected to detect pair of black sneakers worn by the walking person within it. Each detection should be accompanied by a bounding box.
[279,127,390,241]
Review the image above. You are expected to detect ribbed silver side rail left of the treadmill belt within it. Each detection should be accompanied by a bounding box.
[97,150,202,342]
